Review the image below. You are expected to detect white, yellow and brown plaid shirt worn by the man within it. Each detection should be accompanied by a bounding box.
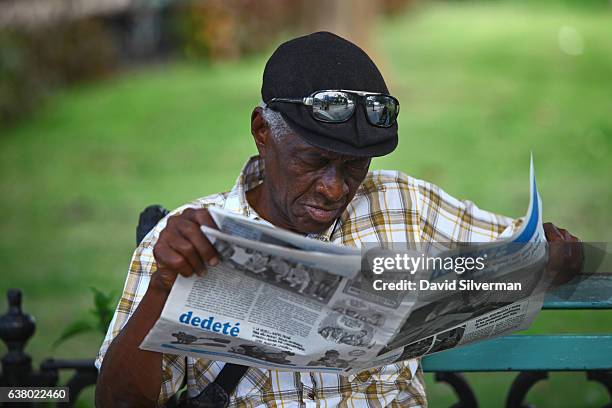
[96,156,518,407]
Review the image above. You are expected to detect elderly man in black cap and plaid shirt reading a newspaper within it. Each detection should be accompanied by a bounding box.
[96,32,579,407]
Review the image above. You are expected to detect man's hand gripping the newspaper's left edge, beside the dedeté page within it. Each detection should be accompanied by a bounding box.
[151,208,219,292]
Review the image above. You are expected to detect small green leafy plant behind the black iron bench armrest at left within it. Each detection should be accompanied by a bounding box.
[53,287,115,348]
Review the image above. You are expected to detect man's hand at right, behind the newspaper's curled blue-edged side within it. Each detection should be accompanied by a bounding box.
[543,222,584,286]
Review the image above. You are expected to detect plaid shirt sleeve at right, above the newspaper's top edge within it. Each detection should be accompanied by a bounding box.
[418,180,522,243]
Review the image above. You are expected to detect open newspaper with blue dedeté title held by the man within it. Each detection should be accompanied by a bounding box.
[140,161,550,375]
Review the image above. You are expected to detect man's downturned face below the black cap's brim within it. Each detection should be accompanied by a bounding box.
[260,124,370,233]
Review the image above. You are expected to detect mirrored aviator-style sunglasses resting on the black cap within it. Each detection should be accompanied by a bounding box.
[268,89,399,127]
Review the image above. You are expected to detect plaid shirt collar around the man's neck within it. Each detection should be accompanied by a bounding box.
[226,155,340,241]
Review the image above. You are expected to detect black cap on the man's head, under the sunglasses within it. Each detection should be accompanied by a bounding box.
[261,32,398,156]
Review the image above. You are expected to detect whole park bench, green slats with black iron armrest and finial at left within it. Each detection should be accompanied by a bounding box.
[0,206,612,408]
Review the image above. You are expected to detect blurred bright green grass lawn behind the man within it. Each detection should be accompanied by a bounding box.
[0,4,612,407]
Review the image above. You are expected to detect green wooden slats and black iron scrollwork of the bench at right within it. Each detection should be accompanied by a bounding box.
[423,273,612,408]
